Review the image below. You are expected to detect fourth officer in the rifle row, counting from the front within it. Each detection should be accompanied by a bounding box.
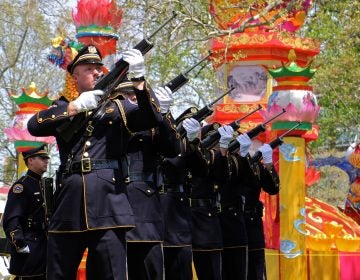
[183,118,227,280]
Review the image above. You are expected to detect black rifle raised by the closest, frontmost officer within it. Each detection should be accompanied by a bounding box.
[57,11,177,142]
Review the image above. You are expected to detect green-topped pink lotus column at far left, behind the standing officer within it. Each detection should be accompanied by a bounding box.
[4,82,55,177]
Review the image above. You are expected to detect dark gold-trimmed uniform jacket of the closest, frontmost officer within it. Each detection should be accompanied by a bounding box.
[28,87,160,232]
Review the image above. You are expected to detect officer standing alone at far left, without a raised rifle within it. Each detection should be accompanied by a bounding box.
[3,145,49,280]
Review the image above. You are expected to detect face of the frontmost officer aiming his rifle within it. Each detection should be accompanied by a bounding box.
[73,64,103,93]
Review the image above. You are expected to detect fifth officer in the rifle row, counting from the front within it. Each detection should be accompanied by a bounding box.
[220,132,251,280]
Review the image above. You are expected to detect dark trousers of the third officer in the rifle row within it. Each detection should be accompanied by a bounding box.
[164,246,192,280]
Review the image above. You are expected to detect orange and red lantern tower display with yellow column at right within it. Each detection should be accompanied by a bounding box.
[209,0,360,280]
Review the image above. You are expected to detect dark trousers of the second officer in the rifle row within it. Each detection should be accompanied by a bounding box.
[127,242,164,280]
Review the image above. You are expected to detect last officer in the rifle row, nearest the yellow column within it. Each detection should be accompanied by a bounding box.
[232,133,279,280]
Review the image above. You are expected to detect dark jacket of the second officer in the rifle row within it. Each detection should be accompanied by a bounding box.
[126,112,180,242]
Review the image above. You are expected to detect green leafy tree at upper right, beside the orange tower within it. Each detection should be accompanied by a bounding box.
[304,0,360,151]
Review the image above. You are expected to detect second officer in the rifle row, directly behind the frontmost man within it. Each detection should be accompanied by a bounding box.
[117,83,180,280]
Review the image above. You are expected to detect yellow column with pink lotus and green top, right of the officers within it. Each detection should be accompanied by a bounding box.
[265,50,320,279]
